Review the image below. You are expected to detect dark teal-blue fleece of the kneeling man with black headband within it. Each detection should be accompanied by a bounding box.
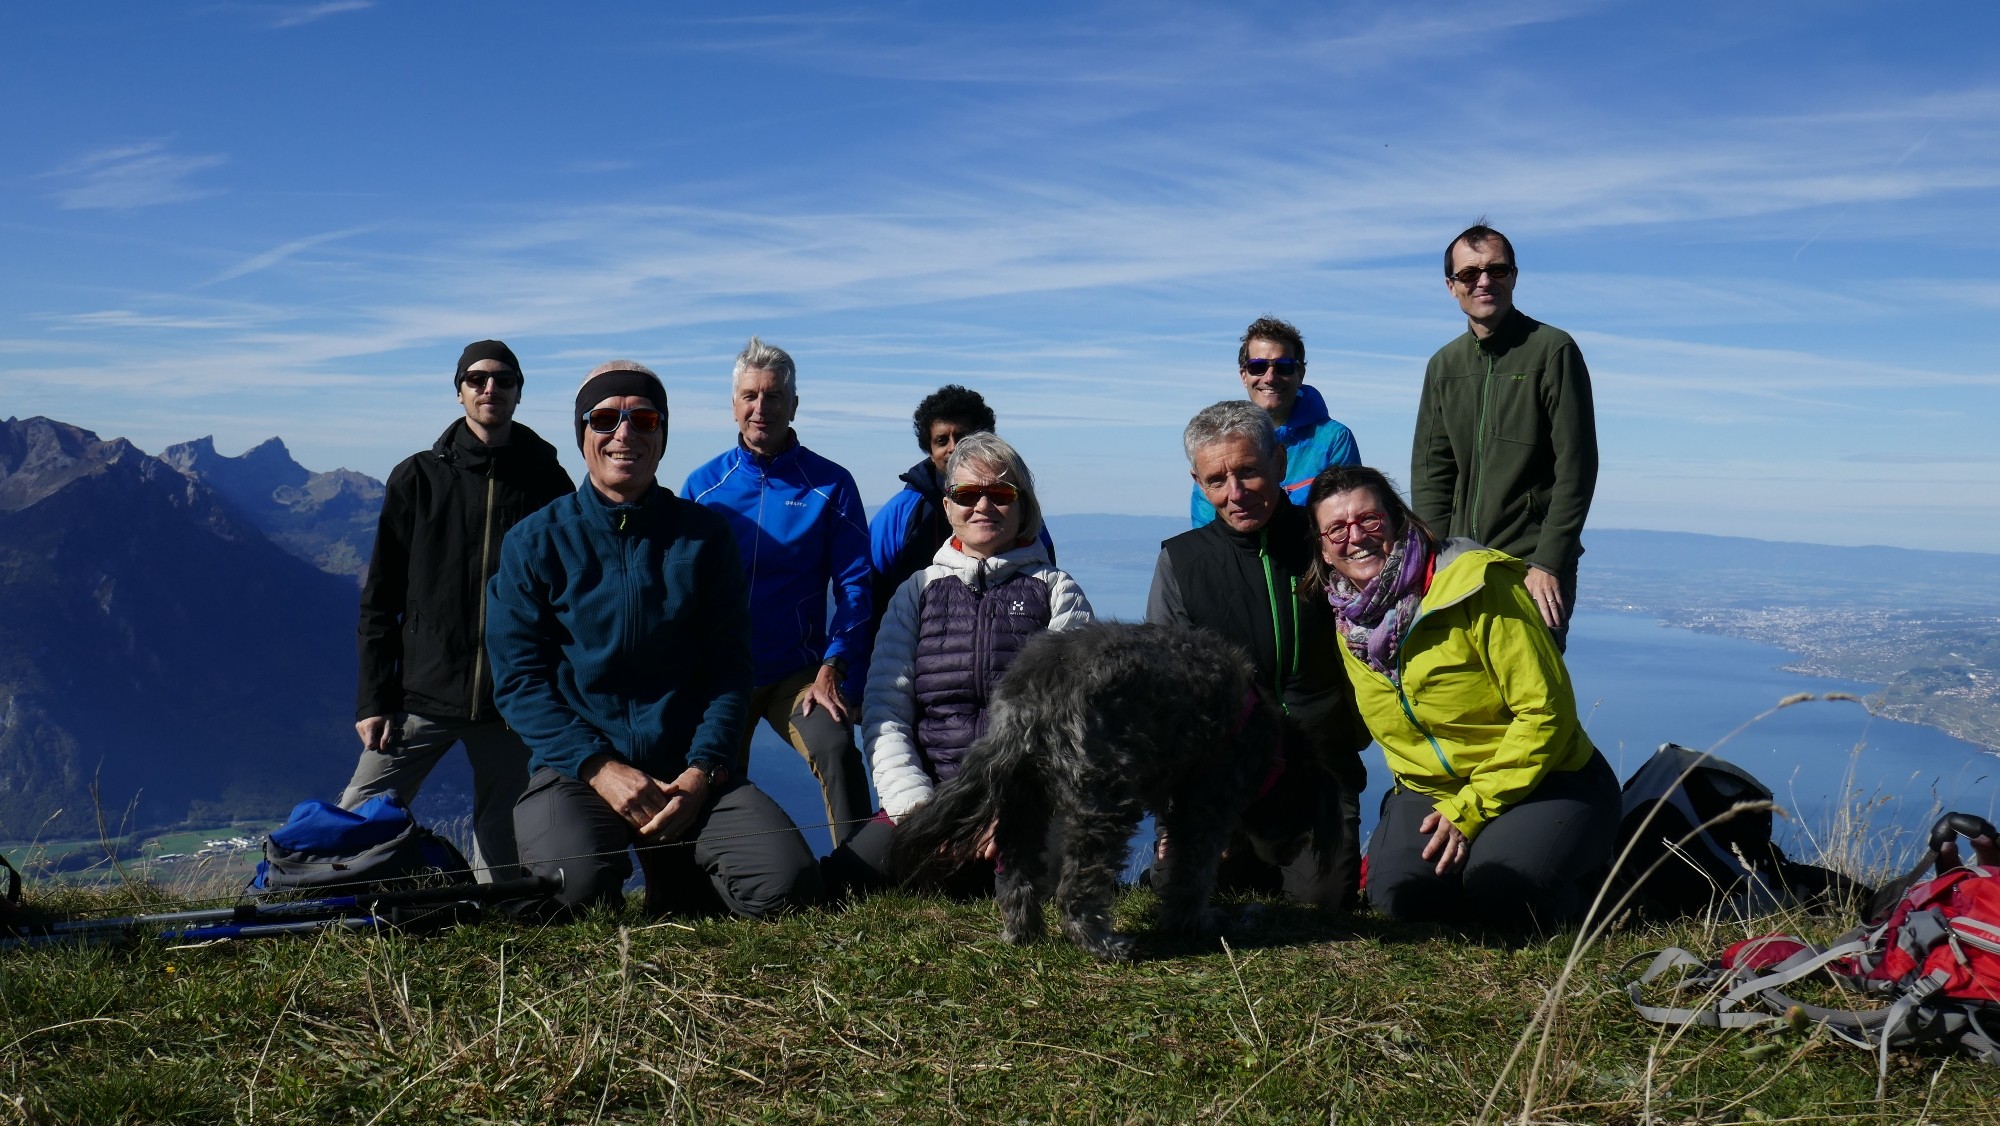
[486,480,750,780]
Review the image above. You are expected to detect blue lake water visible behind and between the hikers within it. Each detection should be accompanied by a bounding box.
[750,576,2000,858]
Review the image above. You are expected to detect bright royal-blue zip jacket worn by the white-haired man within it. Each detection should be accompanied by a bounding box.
[680,438,872,700]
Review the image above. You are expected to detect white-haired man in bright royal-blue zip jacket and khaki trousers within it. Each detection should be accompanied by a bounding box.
[680,336,874,846]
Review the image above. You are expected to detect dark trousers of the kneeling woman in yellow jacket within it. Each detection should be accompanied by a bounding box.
[1368,752,1620,930]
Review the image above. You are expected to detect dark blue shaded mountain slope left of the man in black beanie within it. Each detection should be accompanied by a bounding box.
[0,418,354,838]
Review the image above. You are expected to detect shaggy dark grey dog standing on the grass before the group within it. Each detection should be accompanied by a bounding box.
[894,622,1288,960]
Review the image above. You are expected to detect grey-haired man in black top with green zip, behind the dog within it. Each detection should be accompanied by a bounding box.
[1146,400,1368,910]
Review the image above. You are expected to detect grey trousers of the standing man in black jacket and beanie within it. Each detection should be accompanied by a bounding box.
[340,712,528,884]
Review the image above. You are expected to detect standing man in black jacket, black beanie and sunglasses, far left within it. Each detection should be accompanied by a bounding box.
[340,340,576,880]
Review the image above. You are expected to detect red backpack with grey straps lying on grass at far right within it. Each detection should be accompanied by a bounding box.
[1626,814,2000,1078]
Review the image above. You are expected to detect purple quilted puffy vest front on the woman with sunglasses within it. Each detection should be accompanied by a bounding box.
[916,570,1050,782]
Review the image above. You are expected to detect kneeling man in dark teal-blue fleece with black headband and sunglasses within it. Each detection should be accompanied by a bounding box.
[486,360,820,918]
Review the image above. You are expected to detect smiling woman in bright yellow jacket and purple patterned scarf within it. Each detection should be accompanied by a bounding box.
[1306,466,1620,930]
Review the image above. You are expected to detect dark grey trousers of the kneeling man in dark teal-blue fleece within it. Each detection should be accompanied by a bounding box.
[514,766,820,918]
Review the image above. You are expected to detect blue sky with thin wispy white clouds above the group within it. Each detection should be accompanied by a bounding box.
[0,0,2000,552]
